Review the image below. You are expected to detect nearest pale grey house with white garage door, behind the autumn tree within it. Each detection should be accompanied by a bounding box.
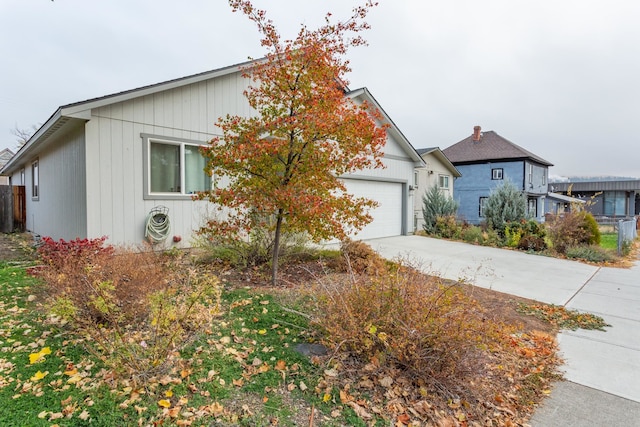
[0,63,424,246]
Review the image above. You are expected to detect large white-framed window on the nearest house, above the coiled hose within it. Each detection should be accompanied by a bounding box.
[143,135,211,198]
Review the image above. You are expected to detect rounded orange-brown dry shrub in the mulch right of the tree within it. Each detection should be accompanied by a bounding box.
[316,254,504,384]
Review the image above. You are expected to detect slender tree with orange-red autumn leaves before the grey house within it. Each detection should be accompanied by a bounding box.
[200,0,386,284]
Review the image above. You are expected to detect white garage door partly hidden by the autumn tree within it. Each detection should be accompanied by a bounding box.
[344,179,402,240]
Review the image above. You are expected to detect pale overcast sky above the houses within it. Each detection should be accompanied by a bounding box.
[0,0,640,177]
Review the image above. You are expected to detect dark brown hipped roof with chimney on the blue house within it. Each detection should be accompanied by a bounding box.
[442,130,553,166]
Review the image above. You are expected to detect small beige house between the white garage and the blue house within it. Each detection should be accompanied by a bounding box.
[413,147,462,230]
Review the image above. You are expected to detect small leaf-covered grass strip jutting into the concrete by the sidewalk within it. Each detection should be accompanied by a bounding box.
[518,303,611,331]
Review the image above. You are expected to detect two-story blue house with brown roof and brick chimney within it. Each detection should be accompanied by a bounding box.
[442,126,553,224]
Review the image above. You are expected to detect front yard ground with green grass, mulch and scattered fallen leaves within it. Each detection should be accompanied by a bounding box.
[0,237,608,426]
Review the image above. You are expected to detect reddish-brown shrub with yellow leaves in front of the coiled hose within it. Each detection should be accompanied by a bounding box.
[38,238,221,384]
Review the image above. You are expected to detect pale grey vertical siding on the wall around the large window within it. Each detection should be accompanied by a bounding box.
[86,73,252,246]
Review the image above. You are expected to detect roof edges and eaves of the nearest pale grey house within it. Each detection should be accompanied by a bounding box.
[0,58,424,174]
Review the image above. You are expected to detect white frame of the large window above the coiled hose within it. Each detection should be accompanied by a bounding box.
[140,134,213,200]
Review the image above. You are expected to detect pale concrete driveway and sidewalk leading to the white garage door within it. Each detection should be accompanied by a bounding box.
[366,236,640,427]
